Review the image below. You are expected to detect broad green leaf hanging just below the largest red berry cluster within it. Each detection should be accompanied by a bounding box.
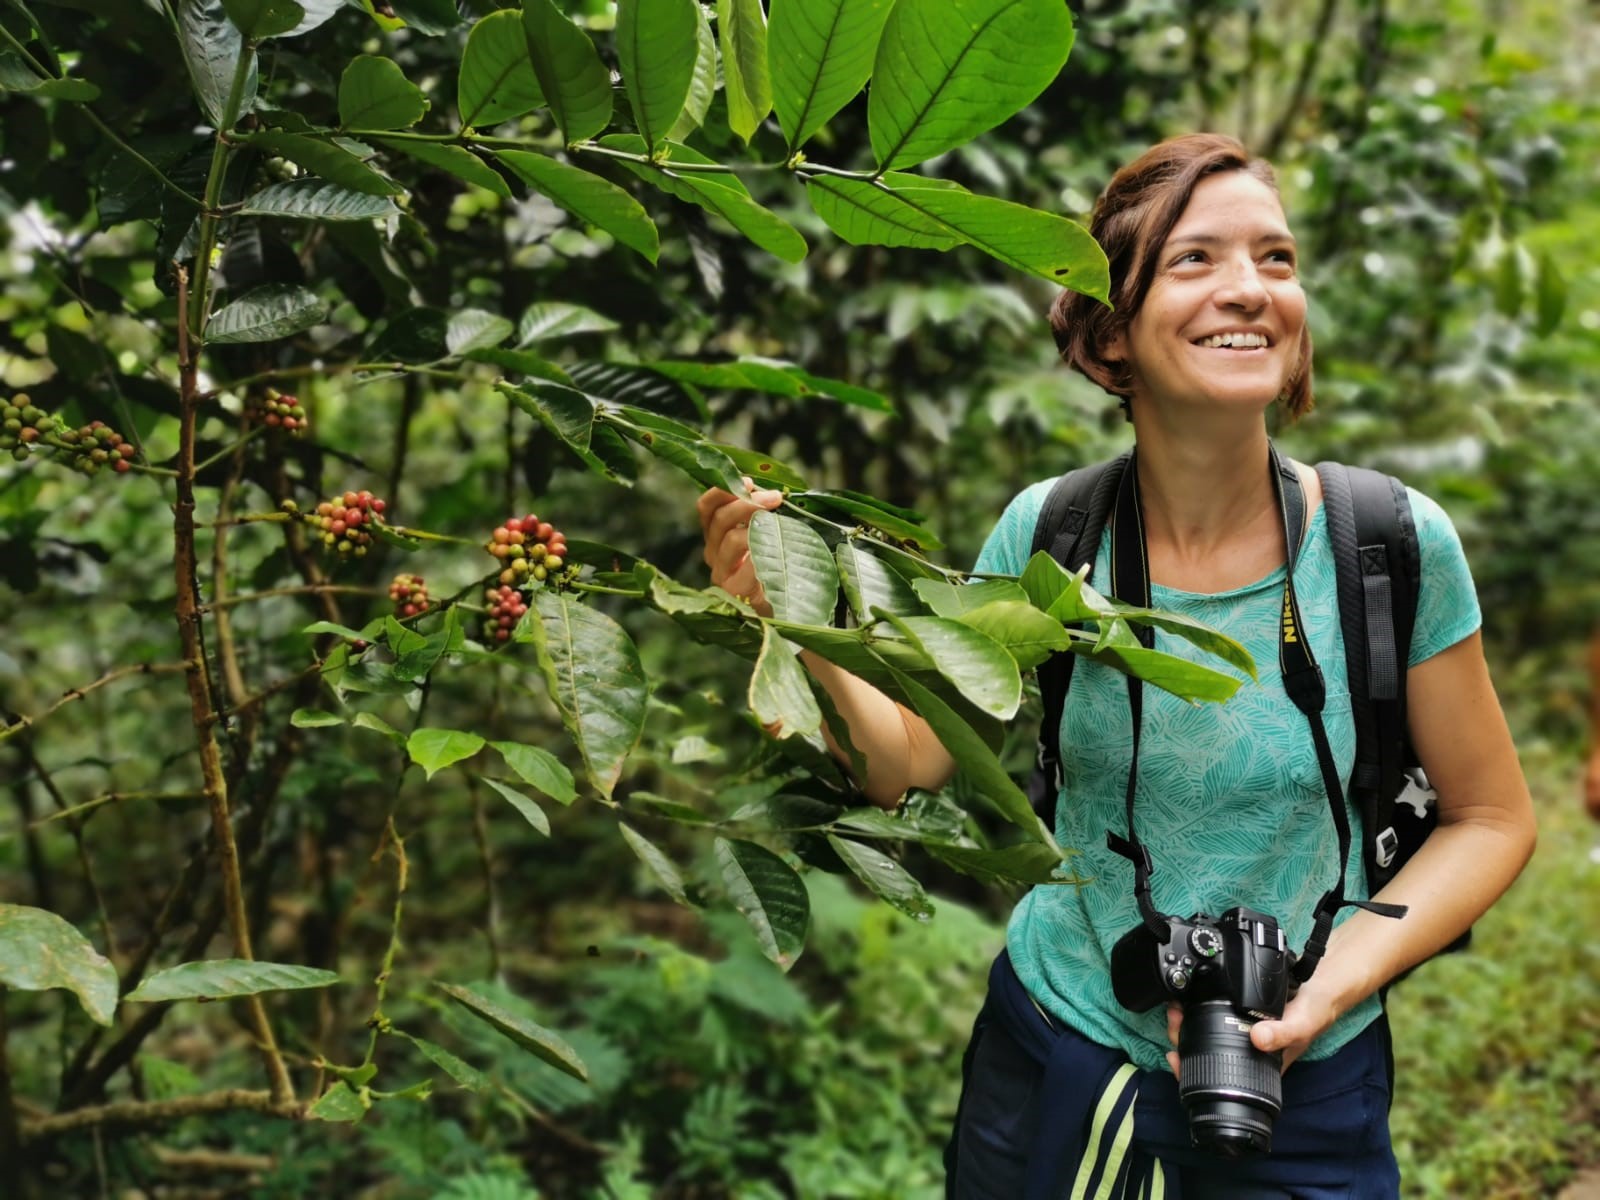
[515,590,648,798]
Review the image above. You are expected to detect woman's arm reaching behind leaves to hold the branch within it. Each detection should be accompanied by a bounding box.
[696,480,955,808]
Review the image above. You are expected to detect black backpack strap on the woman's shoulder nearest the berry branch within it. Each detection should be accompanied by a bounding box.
[1027,451,1133,824]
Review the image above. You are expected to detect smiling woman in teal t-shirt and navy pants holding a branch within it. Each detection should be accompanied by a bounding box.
[699,134,1534,1200]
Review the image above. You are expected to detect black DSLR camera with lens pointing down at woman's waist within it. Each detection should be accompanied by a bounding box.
[1110,907,1296,1158]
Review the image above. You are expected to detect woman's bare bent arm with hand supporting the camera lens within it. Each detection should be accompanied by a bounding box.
[1251,634,1536,1066]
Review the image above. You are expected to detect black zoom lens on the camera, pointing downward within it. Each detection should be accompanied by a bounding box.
[1178,1000,1283,1158]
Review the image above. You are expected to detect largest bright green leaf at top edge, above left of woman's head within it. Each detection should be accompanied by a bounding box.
[867,0,1072,171]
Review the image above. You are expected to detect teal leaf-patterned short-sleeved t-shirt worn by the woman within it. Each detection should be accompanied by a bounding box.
[974,480,1482,1070]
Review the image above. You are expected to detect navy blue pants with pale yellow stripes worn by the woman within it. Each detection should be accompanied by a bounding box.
[946,952,1400,1200]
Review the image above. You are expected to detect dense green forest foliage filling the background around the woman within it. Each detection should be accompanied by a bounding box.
[0,0,1600,1200]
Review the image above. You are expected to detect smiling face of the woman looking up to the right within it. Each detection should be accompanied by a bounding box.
[1106,171,1306,413]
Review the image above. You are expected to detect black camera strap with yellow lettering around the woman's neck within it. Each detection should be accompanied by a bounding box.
[1106,443,1406,982]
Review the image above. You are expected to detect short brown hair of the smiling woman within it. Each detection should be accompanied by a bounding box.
[1050,133,1312,418]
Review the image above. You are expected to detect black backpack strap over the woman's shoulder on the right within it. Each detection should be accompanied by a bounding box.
[1317,462,1421,890]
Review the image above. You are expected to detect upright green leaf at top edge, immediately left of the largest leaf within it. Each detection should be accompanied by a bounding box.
[768,0,893,150]
